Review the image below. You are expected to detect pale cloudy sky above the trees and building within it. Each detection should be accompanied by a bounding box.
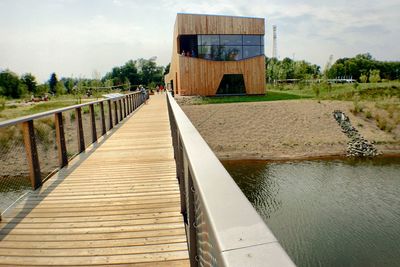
[0,0,400,82]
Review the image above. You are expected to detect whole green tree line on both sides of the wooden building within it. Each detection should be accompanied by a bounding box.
[0,53,400,98]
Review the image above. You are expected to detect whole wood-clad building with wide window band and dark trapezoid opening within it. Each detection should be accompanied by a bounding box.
[165,14,265,96]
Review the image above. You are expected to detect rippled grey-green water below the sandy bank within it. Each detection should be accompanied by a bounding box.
[223,158,400,267]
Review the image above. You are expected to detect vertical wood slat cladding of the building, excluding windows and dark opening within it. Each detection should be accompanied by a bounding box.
[165,14,265,96]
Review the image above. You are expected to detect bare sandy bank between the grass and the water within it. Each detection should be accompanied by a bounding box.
[181,100,400,160]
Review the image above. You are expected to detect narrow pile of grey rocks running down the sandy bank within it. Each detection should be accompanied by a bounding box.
[333,110,378,157]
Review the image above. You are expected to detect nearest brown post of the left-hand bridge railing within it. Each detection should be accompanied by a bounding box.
[22,120,42,190]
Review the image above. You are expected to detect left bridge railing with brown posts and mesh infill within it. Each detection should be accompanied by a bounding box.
[0,92,144,220]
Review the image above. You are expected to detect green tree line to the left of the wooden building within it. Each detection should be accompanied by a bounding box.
[0,57,169,99]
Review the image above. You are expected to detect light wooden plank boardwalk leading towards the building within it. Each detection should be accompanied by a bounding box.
[0,95,189,266]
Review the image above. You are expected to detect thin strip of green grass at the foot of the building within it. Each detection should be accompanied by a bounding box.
[197,91,310,104]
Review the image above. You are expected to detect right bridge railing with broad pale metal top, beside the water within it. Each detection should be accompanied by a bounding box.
[167,93,294,267]
